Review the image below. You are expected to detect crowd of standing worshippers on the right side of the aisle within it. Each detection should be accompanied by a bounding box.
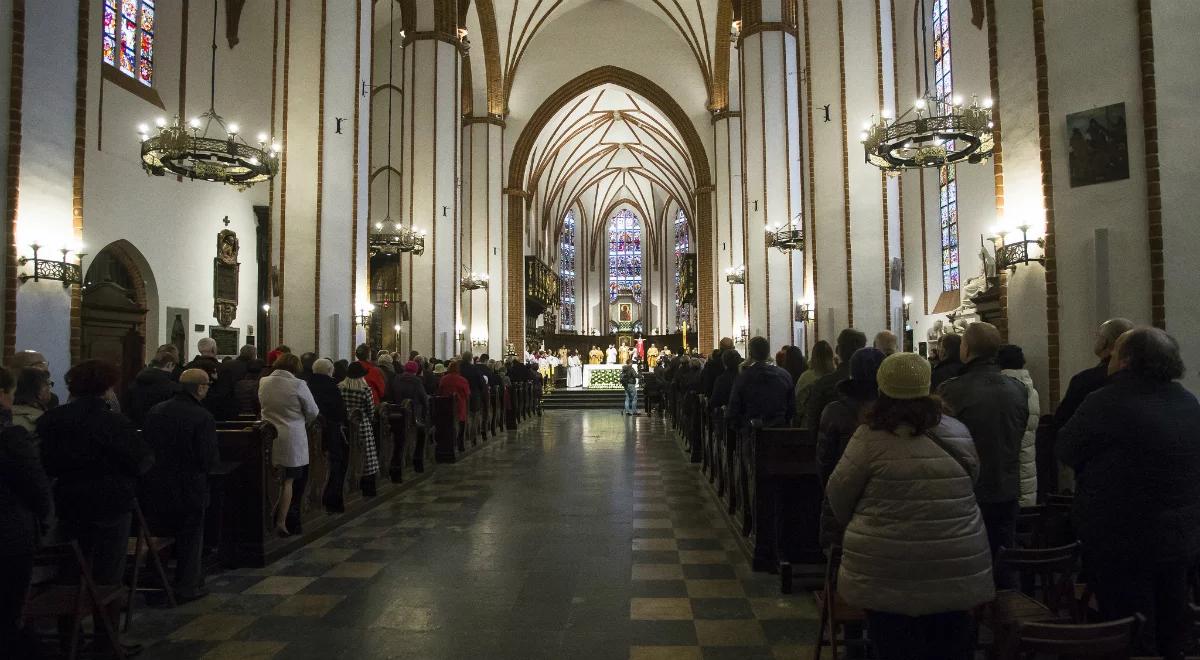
[647,318,1200,660]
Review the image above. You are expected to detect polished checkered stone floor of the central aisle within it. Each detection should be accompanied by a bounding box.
[131,410,816,660]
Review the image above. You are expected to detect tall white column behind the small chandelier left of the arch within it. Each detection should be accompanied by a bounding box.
[401,11,461,358]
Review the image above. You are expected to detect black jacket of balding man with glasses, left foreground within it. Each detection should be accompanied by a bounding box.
[139,392,221,514]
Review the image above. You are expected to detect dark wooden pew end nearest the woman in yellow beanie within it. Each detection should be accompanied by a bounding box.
[746,427,824,570]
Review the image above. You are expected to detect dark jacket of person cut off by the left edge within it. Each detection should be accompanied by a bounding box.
[0,426,50,557]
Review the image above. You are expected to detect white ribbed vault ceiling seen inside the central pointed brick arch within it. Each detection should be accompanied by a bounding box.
[526,84,696,259]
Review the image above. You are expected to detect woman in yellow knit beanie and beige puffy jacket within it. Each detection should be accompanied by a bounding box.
[826,353,995,660]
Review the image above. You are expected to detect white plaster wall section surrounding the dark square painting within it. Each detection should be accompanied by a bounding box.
[1045,0,1152,385]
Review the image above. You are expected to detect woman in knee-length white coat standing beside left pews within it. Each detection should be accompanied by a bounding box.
[258,353,318,536]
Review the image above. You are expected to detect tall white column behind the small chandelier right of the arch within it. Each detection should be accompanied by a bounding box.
[739,0,804,348]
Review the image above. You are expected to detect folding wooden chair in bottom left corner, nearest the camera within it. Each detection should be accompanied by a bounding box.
[22,541,128,660]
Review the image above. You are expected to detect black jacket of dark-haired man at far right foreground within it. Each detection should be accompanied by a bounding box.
[1055,372,1200,562]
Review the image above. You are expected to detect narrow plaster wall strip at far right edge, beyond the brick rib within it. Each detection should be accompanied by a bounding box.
[1152,0,1200,392]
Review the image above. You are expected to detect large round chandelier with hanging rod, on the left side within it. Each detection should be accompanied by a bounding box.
[138,0,281,190]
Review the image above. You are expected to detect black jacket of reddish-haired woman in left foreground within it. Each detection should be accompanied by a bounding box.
[37,396,154,522]
